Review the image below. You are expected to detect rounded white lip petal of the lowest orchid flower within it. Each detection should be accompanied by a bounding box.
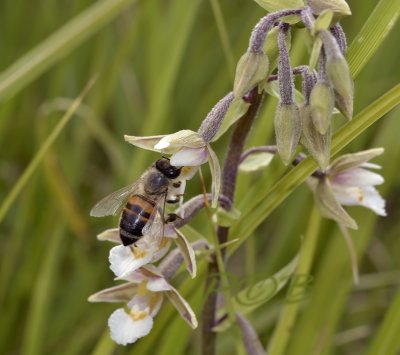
[108,308,153,345]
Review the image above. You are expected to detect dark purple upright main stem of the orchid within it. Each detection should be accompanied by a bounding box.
[202,88,263,355]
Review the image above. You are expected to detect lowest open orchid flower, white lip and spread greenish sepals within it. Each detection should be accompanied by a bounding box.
[88,265,197,345]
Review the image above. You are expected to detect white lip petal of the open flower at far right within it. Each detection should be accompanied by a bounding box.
[333,186,386,216]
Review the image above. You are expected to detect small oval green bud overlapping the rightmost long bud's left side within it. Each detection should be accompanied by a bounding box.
[310,81,334,134]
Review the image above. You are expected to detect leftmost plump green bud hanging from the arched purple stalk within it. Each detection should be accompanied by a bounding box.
[233,52,269,97]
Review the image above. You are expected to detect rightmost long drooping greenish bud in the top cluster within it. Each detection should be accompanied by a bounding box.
[319,31,354,120]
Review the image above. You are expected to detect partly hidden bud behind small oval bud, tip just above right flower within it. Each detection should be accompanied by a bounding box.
[300,105,332,170]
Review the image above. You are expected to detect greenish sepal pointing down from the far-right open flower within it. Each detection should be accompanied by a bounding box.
[315,179,358,229]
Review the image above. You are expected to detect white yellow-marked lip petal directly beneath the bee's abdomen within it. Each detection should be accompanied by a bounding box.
[108,245,153,278]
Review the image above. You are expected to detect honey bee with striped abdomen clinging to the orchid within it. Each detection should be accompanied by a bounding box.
[90,158,182,246]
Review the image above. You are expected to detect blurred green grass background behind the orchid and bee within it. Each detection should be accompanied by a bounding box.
[0,0,400,354]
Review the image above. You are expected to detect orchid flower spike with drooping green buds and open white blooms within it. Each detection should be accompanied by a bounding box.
[89,0,386,350]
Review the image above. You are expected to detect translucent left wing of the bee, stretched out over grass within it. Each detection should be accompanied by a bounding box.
[90,179,141,217]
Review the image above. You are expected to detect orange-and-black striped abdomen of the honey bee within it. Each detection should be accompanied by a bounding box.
[119,195,155,246]
